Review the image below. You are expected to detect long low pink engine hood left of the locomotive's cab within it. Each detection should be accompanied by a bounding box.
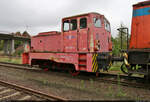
[31,31,62,52]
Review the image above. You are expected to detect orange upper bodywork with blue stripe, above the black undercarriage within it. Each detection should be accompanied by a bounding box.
[129,1,150,49]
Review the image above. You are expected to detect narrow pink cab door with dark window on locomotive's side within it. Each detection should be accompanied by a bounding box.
[77,16,89,52]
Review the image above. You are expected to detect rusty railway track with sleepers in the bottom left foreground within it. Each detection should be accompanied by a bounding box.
[0,80,67,101]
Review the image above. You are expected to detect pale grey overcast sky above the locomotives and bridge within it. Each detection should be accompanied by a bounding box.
[0,0,144,36]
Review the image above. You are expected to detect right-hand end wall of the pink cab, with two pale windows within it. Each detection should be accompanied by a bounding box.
[93,15,111,52]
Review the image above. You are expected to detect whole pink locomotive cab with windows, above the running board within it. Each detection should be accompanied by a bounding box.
[62,13,112,52]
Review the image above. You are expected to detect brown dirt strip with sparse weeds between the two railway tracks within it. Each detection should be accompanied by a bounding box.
[0,67,150,100]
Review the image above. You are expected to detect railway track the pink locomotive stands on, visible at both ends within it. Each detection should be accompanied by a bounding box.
[0,62,150,90]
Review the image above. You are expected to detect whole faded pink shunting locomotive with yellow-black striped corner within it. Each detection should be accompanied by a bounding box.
[22,13,112,75]
